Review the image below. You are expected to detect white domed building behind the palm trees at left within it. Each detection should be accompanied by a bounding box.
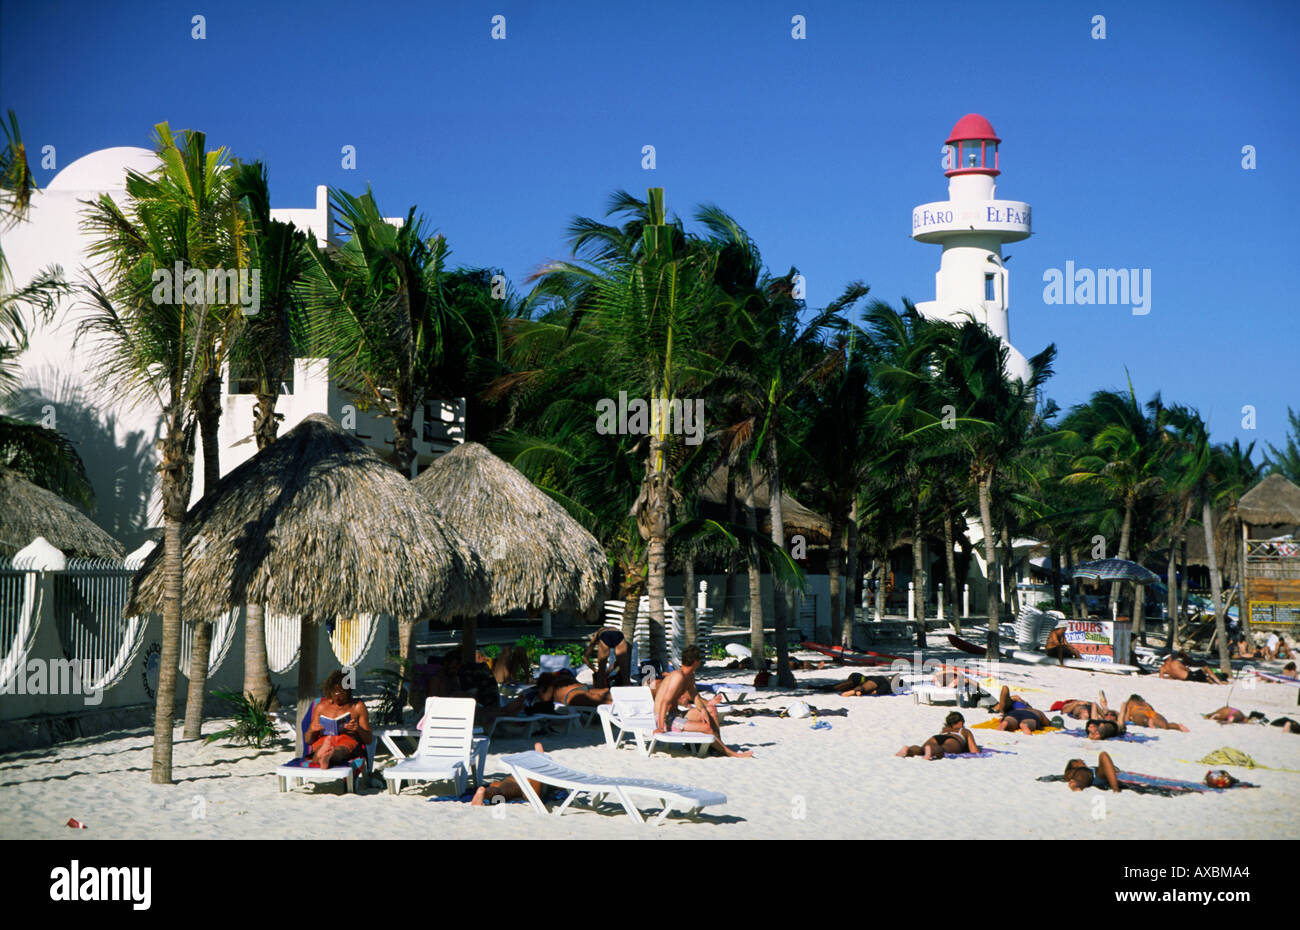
[4,147,464,550]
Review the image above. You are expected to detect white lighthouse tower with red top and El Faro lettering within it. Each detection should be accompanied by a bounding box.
[911,113,1030,381]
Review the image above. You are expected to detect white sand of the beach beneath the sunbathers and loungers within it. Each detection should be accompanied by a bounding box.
[0,647,1300,839]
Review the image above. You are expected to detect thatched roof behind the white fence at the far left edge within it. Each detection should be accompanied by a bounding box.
[0,468,122,559]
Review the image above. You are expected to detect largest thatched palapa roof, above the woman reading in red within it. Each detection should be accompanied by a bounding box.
[126,414,488,620]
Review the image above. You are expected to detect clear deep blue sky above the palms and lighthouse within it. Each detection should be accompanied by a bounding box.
[0,0,1300,459]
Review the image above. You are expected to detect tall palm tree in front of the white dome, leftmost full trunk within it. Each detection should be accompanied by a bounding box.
[77,124,238,784]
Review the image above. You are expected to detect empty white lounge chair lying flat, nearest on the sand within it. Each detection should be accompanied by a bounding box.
[501,752,727,825]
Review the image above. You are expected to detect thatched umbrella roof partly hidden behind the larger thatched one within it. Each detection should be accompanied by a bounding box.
[412,442,610,614]
